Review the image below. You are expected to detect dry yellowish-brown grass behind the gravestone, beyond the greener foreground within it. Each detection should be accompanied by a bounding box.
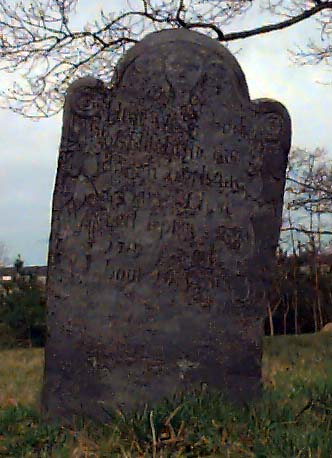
[0,333,332,409]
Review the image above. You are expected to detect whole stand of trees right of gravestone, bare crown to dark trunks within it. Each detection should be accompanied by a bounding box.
[265,148,332,335]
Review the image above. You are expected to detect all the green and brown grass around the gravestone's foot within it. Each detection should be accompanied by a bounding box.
[0,333,332,458]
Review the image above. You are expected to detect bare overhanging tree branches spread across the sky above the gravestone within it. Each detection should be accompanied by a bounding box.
[0,0,332,117]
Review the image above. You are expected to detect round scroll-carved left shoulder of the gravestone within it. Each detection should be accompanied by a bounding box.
[65,77,109,118]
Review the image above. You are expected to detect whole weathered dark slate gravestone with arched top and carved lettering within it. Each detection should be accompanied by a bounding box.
[42,29,291,420]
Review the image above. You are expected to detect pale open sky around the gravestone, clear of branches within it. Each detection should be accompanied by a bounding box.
[0,0,332,265]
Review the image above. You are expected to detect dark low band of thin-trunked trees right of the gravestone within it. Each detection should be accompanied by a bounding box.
[264,250,332,336]
